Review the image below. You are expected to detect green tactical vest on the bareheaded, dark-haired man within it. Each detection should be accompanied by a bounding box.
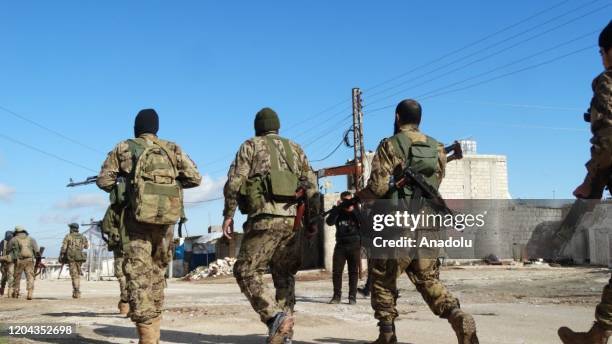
[388,132,441,198]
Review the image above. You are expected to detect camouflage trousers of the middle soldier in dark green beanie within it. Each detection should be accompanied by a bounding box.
[234,217,301,323]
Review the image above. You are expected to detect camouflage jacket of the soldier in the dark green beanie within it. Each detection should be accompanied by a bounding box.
[223,134,317,218]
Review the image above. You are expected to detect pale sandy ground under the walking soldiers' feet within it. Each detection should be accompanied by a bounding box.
[0,266,610,344]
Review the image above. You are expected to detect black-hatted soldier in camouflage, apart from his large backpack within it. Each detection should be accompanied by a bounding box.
[97,109,202,344]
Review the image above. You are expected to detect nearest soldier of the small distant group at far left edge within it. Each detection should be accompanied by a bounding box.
[9,226,40,300]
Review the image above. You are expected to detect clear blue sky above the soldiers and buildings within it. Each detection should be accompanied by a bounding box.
[0,0,611,252]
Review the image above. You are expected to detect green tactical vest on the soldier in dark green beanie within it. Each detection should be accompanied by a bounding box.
[238,136,300,215]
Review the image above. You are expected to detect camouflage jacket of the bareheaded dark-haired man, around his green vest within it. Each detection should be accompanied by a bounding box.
[359,125,446,199]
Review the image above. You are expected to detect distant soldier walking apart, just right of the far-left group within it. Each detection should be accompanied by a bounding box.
[60,223,89,299]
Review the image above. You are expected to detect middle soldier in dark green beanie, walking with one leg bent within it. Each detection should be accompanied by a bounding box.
[223,108,319,343]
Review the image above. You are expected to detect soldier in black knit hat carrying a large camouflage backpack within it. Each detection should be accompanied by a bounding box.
[96,109,202,344]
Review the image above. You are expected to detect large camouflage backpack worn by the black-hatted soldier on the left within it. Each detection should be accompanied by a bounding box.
[127,138,183,225]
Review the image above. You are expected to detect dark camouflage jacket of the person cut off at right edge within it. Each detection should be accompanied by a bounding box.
[586,70,612,181]
